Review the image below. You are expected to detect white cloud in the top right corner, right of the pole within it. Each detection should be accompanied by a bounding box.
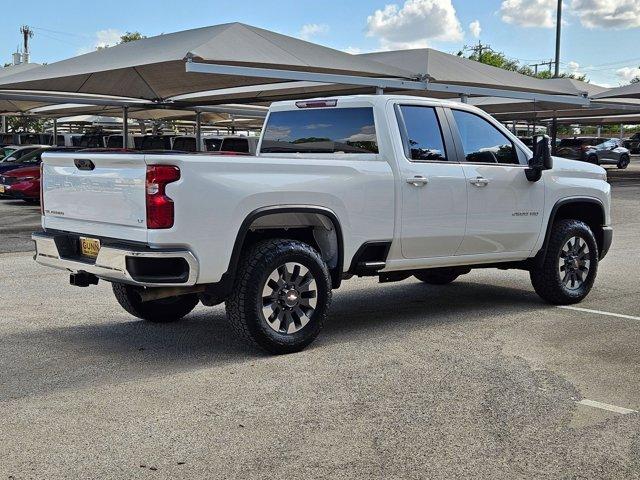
[571,0,640,29]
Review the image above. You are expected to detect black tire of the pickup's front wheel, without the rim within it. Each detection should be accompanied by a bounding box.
[529,220,598,305]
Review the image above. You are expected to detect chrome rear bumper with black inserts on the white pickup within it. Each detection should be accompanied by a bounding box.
[31,232,199,287]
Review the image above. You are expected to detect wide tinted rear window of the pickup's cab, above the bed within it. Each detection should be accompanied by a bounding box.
[261,107,378,153]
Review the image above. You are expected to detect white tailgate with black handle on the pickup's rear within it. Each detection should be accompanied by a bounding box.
[42,152,146,241]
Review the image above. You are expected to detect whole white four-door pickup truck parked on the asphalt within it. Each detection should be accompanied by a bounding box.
[33,95,613,353]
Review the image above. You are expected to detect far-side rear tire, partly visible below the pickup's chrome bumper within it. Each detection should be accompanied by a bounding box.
[112,283,199,323]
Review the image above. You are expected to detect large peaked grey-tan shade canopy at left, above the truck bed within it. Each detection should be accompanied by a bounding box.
[0,23,407,101]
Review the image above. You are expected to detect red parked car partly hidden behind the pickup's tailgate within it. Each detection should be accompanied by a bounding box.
[0,146,82,203]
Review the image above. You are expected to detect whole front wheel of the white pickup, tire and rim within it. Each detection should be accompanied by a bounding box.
[529,220,598,305]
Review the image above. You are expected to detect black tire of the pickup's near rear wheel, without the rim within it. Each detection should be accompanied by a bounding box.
[226,239,331,354]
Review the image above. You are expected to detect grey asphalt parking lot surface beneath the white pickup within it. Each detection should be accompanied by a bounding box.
[0,159,640,479]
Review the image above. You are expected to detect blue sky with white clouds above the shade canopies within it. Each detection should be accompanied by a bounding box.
[0,0,640,86]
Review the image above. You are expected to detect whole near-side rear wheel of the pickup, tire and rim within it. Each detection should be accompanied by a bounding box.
[226,239,331,354]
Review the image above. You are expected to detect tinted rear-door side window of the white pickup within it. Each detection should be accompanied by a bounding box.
[400,105,447,161]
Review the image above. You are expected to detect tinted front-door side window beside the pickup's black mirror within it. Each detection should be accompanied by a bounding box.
[452,110,519,164]
